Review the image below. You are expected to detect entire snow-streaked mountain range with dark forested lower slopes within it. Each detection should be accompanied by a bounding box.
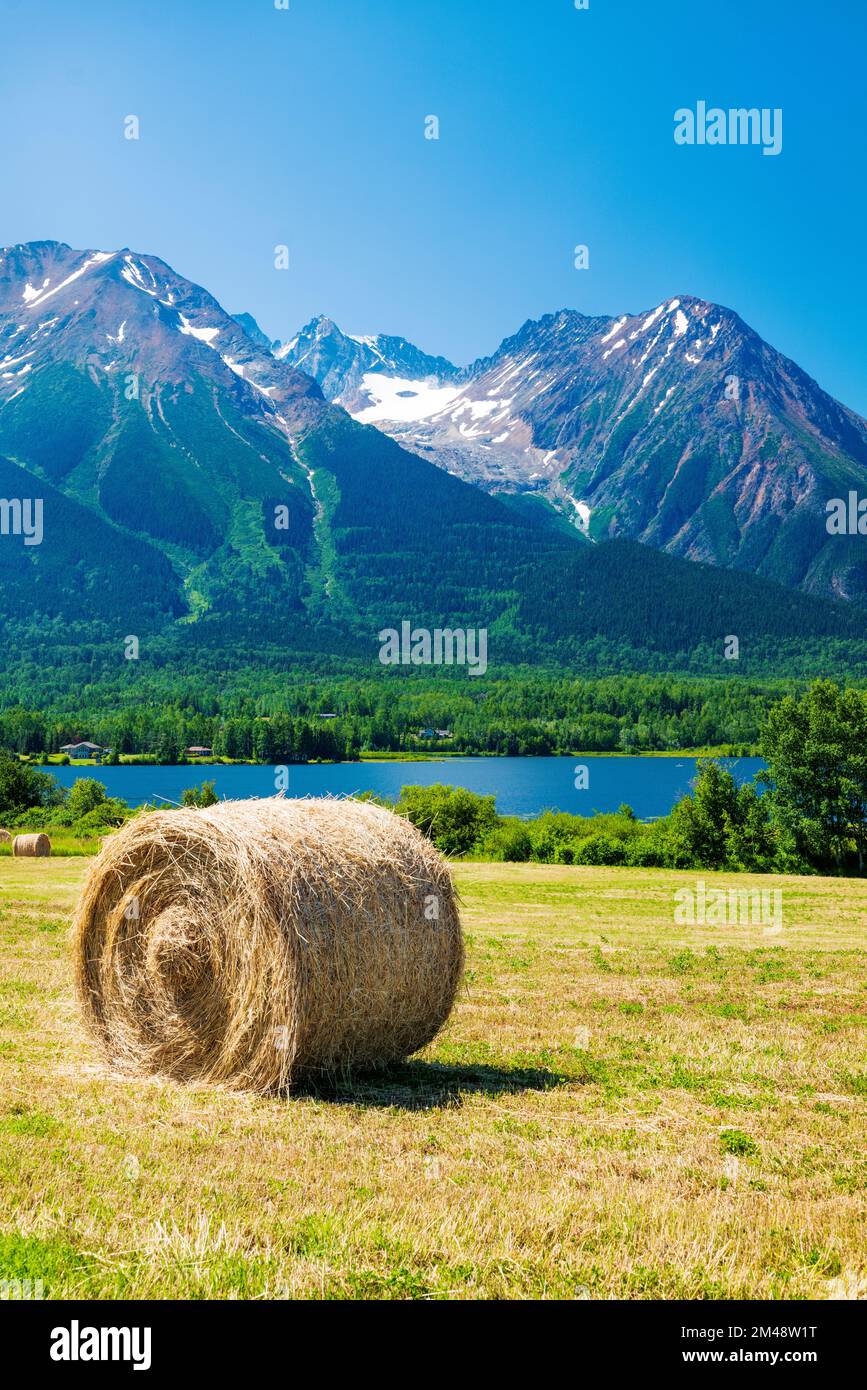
[0,242,867,683]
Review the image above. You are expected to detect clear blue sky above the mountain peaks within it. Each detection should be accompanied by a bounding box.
[6,0,867,414]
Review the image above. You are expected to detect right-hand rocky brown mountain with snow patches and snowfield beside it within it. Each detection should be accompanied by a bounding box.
[284,296,867,599]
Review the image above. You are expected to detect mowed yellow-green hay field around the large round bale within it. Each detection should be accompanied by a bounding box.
[0,859,867,1300]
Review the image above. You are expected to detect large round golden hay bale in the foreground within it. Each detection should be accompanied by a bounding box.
[74,798,464,1091]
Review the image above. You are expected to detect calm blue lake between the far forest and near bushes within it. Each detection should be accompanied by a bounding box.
[51,756,764,819]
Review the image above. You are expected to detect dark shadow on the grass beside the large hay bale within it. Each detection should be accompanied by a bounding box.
[290,1062,568,1111]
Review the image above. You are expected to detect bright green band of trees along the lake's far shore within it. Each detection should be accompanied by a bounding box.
[0,670,798,763]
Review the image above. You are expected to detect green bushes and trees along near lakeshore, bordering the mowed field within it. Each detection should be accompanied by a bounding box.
[0,681,867,874]
